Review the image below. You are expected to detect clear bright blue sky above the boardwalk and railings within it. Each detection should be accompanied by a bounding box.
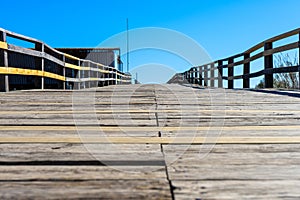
[0,0,300,85]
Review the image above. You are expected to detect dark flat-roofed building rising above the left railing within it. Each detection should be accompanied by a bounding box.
[55,48,123,71]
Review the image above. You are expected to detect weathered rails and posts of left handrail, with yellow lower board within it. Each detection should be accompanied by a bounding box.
[0,28,131,91]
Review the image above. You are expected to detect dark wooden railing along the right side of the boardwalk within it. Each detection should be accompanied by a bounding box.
[182,29,300,89]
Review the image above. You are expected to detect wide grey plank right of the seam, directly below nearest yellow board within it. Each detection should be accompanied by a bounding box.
[163,144,300,167]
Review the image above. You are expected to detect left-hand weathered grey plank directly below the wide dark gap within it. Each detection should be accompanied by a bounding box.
[0,163,166,182]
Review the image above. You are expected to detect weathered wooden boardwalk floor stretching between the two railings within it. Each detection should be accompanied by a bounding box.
[0,85,300,199]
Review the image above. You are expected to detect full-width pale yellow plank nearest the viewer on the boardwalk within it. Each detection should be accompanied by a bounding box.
[0,134,300,144]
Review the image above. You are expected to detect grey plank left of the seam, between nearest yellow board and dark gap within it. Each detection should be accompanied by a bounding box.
[0,143,165,162]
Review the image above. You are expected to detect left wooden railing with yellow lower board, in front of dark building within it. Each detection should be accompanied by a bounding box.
[0,29,131,91]
